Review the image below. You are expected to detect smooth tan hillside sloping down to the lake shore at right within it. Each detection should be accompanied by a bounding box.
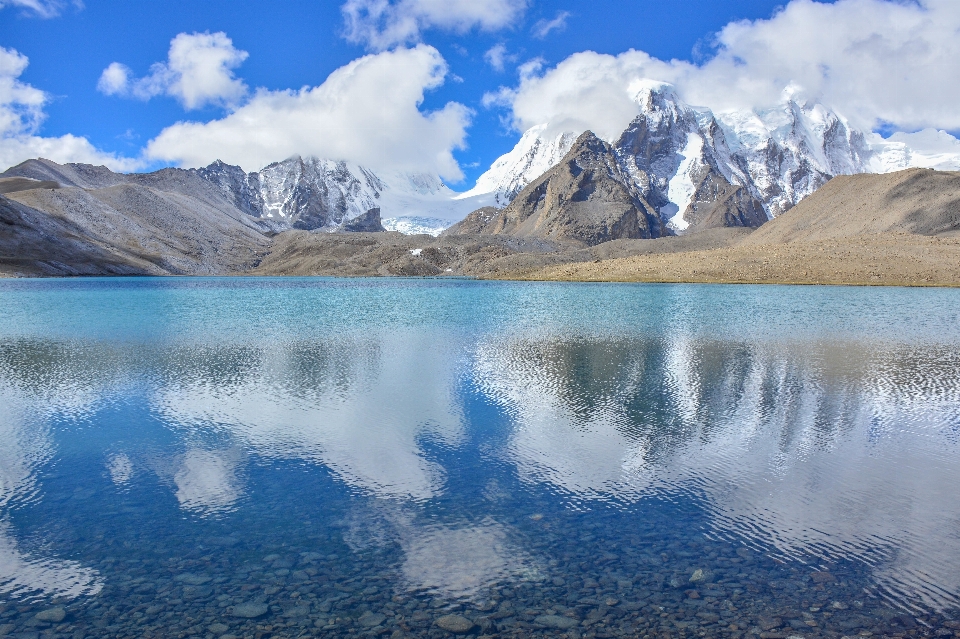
[503,169,960,286]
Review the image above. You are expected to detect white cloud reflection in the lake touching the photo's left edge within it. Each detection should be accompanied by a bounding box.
[0,383,102,597]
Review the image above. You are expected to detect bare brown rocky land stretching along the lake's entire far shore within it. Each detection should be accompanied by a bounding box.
[0,164,960,286]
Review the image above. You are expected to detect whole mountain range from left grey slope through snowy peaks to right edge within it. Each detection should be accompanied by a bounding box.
[0,82,960,274]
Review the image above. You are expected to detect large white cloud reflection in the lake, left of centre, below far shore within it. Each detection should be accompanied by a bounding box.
[154,334,462,499]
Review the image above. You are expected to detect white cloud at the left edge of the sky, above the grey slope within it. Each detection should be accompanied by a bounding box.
[0,47,139,171]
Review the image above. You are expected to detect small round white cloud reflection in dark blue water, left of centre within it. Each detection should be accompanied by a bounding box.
[173,448,243,515]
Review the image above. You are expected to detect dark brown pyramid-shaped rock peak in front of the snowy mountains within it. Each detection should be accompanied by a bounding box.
[445,131,664,246]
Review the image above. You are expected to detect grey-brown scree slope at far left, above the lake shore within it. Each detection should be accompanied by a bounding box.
[0,169,270,275]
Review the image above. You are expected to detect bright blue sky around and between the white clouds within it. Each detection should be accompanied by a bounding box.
[0,0,960,189]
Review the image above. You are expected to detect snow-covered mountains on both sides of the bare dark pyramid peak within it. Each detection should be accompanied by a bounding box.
[196,80,960,235]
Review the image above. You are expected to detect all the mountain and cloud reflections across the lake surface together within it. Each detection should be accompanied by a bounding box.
[0,318,960,608]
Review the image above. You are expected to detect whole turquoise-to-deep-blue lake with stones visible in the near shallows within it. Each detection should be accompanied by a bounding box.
[0,279,960,639]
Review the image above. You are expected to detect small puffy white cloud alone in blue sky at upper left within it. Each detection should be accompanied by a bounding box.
[97,32,248,109]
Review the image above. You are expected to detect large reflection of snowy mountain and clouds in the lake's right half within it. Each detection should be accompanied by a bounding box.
[476,340,960,608]
